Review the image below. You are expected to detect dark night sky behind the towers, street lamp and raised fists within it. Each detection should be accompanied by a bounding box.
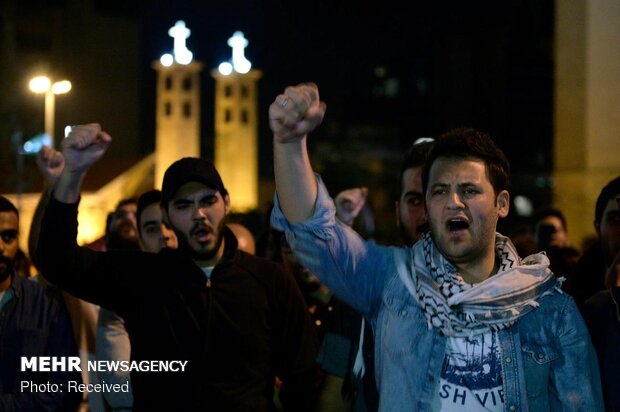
[0,0,554,237]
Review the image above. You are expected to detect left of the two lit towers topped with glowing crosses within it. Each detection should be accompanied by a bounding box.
[152,21,203,188]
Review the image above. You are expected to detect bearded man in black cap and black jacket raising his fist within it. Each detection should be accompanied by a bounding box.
[38,124,318,412]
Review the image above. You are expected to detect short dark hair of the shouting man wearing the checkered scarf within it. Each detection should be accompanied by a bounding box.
[422,127,510,194]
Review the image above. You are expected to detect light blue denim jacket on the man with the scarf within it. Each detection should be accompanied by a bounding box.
[272,175,603,412]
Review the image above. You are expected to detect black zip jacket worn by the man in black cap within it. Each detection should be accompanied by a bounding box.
[37,199,318,412]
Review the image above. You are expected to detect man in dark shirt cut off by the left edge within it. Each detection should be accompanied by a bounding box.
[0,196,82,411]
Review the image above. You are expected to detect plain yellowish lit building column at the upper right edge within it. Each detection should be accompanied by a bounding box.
[553,0,620,245]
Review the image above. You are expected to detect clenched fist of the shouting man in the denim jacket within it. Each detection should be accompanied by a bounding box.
[269,83,326,143]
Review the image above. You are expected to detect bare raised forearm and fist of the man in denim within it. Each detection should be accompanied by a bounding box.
[269,83,326,223]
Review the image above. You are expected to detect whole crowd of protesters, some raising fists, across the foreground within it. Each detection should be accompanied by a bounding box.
[0,83,620,412]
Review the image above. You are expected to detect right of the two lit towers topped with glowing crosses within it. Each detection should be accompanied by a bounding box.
[211,31,262,212]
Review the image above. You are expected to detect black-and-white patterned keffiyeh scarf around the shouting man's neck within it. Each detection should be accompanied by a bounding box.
[396,233,563,337]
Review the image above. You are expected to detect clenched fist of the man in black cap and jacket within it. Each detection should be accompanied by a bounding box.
[61,123,112,173]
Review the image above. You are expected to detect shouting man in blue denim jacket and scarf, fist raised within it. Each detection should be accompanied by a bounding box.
[269,84,602,411]
